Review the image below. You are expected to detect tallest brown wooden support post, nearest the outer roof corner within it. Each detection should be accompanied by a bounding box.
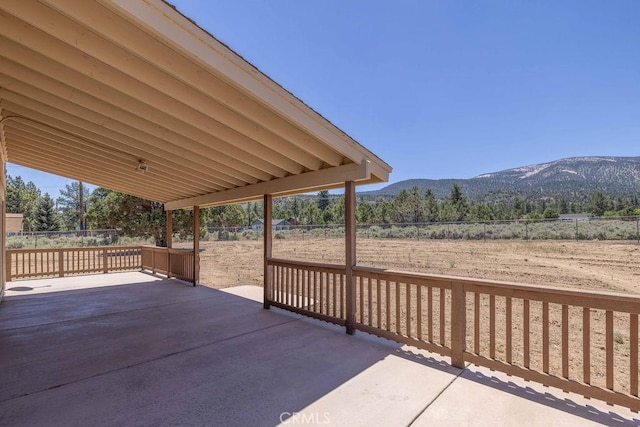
[344,181,362,335]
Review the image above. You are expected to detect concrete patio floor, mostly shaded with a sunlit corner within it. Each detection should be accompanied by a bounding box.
[0,273,640,426]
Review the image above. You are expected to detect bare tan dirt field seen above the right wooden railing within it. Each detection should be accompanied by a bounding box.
[200,238,640,294]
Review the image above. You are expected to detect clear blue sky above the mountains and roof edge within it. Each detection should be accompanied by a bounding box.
[8,0,640,194]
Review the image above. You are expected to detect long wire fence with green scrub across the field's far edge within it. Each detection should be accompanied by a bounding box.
[6,216,640,249]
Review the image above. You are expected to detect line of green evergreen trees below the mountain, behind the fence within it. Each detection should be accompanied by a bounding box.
[7,176,640,241]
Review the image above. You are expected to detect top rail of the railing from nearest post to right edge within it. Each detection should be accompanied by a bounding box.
[354,266,640,312]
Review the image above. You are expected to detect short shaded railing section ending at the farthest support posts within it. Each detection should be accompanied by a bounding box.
[142,246,194,282]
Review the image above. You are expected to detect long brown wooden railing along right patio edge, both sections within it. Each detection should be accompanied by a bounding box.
[267,260,640,411]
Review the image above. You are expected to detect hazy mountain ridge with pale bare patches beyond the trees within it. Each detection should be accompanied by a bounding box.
[359,156,640,200]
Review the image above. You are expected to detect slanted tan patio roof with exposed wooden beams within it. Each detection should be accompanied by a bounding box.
[0,0,391,209]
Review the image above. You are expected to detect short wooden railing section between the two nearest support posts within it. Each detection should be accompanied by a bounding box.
[267,259,346,325]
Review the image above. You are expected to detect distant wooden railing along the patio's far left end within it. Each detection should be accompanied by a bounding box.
[5,246,142,281]
